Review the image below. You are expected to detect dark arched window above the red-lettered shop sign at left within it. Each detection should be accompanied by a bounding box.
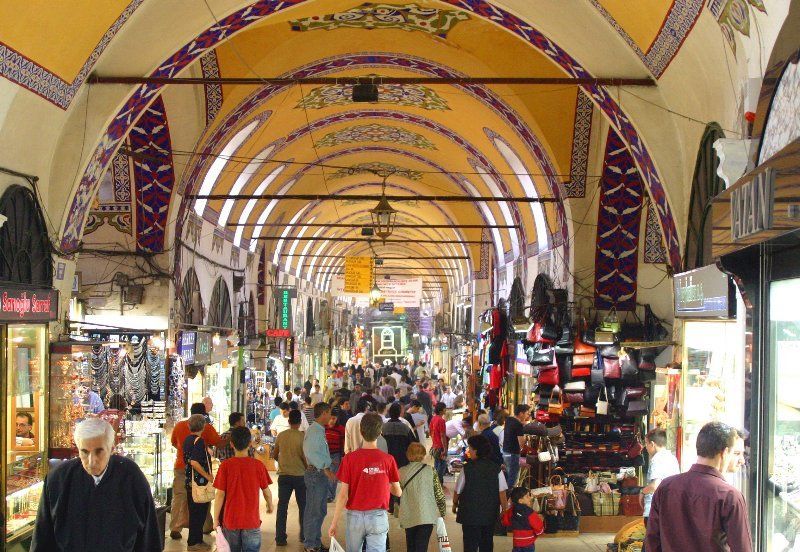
[0,185,53,287]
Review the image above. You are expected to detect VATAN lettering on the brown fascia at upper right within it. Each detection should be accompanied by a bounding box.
[731,168,775,241]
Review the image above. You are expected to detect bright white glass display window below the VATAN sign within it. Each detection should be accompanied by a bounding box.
[765,279,800,552]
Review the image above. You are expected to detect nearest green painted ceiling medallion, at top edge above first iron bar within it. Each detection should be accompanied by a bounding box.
[289,2,469,38]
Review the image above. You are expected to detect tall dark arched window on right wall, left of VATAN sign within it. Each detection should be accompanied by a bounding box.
[683,123,725,270]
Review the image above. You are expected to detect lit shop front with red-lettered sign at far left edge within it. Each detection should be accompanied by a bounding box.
[0,284,58,548]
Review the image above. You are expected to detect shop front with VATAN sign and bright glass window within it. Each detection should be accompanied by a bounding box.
[713,137,800,552]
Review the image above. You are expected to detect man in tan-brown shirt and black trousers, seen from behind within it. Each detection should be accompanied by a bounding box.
[272,410,306,546]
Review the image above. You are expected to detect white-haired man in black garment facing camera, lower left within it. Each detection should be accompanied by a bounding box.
[30,418,163,552]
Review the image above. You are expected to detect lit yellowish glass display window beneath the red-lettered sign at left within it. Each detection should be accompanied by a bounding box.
[4,325,47,540]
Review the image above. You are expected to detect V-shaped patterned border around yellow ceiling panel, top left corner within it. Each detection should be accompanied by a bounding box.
[0,0,144,109]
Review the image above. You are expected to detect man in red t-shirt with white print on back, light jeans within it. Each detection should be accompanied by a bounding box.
[328,412,403,552]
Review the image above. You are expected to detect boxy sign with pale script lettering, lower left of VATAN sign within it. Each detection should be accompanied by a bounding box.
[672,265,735,318]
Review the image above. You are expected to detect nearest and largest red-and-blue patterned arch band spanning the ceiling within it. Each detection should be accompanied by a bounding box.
[51,0,680,272]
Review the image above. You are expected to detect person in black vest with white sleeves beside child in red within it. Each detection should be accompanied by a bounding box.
[453,435,508,552]
